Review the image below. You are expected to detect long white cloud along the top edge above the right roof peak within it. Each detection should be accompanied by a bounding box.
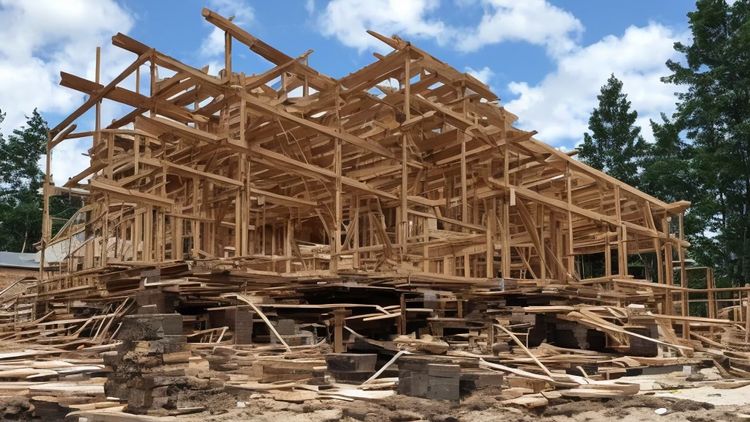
[308,0,583,54]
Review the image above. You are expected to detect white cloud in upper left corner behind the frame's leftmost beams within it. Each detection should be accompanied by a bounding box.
[0,0,135,183]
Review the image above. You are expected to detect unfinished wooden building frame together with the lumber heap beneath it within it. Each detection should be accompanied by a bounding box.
[0,4,750,420]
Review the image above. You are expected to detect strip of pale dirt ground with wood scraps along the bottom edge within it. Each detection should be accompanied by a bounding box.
[0,374,750,422]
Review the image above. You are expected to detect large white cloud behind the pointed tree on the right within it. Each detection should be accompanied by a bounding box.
[506,23,684,146]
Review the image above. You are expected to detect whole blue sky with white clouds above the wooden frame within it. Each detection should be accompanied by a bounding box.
[0,0,694,180]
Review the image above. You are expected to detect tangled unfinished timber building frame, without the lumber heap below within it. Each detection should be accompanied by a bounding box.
[37,9,747,338]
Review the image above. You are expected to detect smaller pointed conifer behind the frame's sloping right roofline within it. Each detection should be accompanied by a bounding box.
[578,75,645,186]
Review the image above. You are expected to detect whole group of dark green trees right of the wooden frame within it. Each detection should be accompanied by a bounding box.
[579,0,750,285]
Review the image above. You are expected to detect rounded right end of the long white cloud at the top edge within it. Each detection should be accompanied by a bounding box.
[456,0,583,55]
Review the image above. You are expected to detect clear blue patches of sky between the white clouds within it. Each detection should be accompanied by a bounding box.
[122,0,694,103]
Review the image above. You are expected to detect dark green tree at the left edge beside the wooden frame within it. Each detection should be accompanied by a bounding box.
[0,110,77,252]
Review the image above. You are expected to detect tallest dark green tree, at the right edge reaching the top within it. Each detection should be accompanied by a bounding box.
[664,0,750,284]
